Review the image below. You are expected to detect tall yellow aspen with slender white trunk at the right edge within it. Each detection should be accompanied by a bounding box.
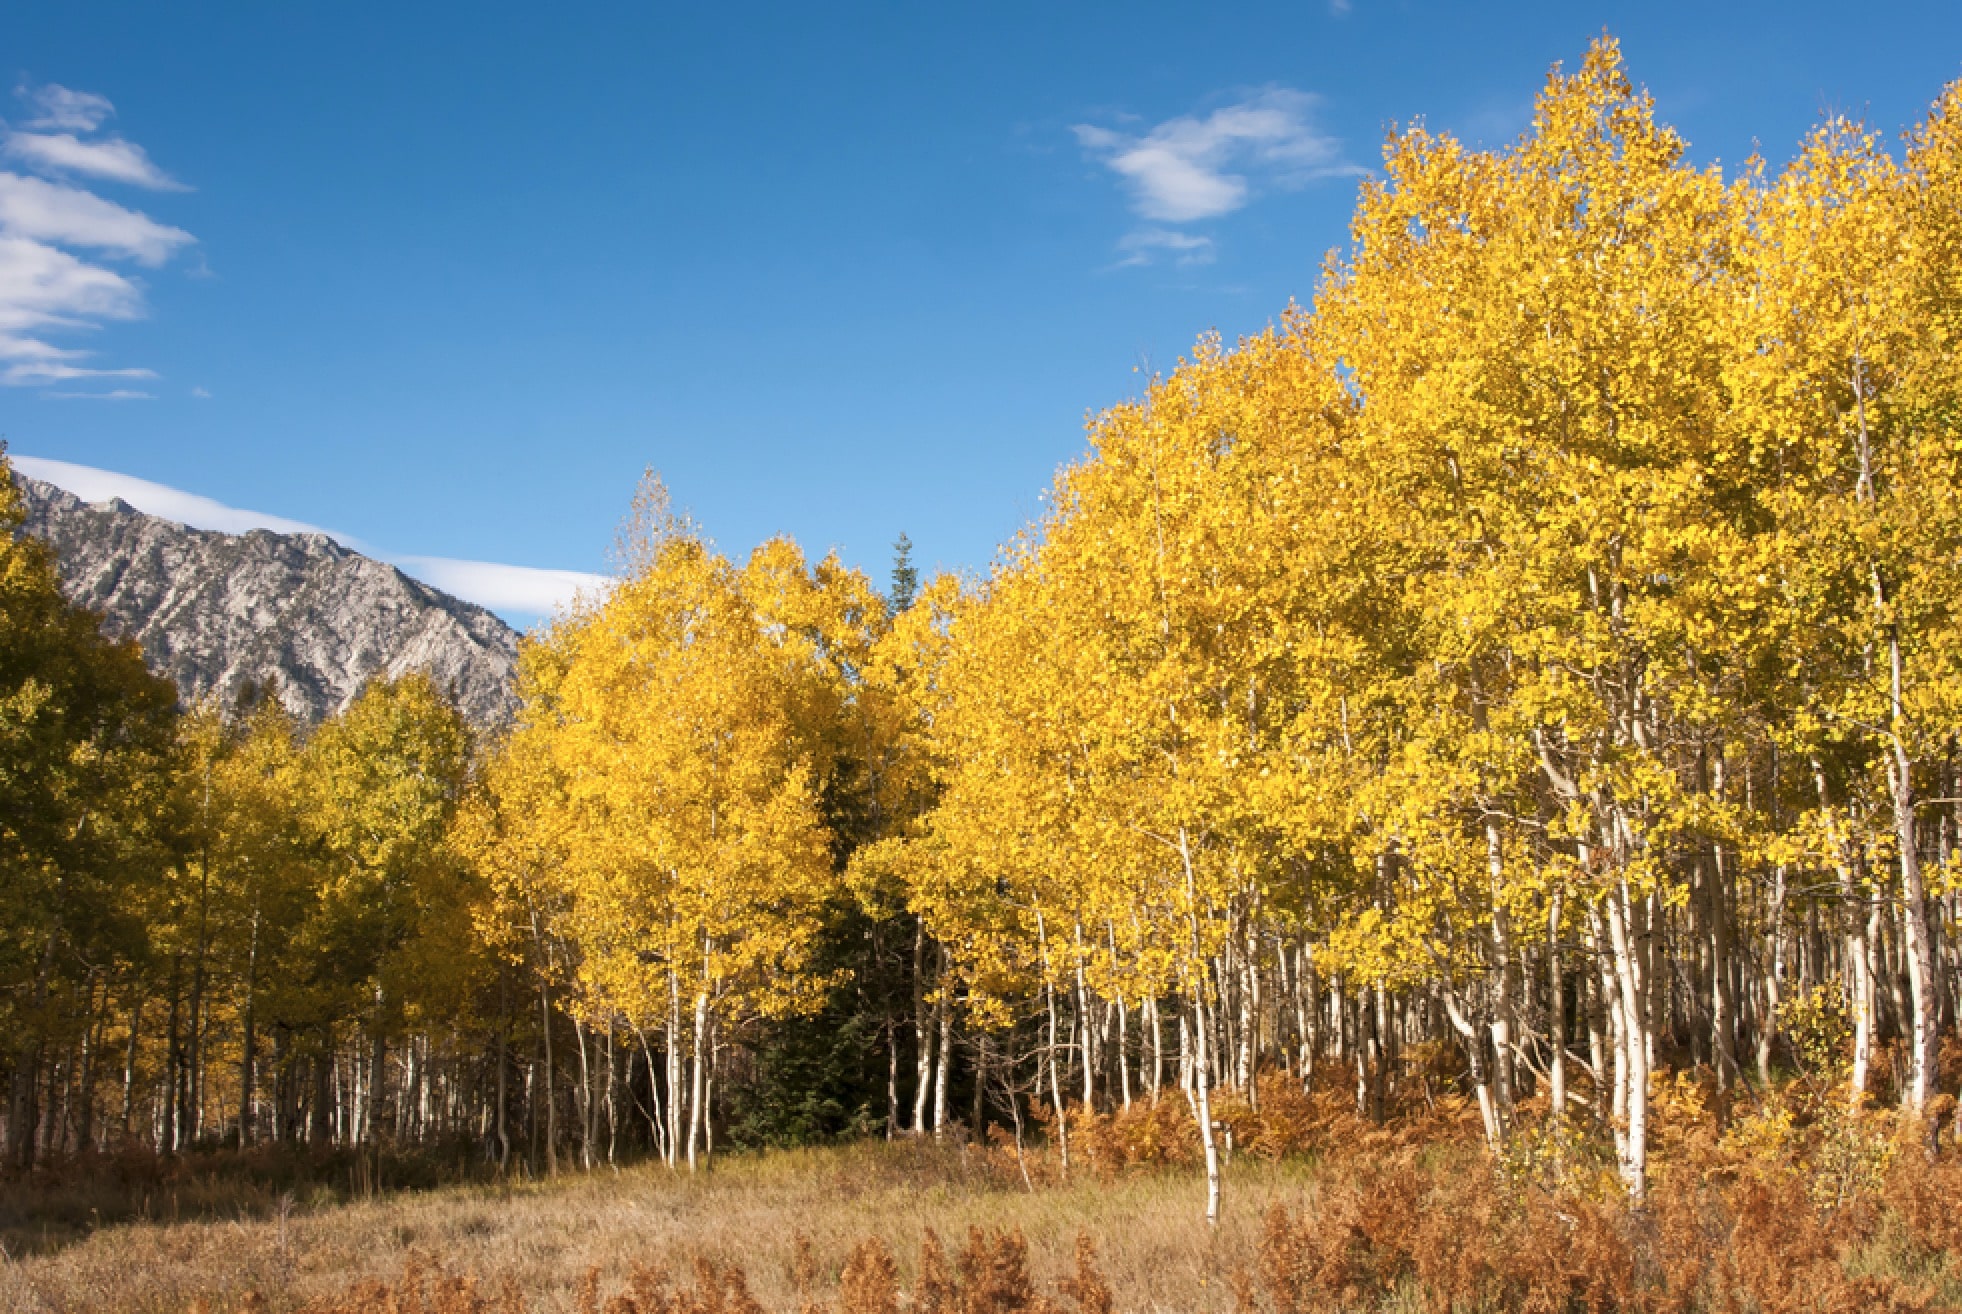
[1738,112,1962,1110]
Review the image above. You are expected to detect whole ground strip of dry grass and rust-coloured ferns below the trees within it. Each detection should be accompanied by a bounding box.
[11,1081,1962,1314]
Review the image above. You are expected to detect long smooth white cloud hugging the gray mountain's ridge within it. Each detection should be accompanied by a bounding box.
[10,458,612,618]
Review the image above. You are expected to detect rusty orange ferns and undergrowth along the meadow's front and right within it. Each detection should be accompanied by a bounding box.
[206,1073,1962,1314]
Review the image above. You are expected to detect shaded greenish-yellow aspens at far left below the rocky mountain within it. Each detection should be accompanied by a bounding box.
[0,453,494,1169]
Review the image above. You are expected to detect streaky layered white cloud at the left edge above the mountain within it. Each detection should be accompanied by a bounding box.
[0,84,196,400]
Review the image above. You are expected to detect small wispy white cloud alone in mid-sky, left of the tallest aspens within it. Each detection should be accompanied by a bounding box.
[1073,86,1362,265]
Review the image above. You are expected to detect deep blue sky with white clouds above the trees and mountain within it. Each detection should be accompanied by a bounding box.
[0,0,1962,622]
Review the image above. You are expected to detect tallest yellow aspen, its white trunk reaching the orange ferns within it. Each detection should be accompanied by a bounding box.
[1322,41,1729,1194]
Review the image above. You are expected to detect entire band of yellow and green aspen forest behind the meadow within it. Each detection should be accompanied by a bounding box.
[0,41,1962,1239]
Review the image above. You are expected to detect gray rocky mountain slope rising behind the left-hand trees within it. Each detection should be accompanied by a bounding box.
[16,475,518,726]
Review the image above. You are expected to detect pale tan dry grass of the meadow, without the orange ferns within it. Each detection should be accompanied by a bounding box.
[0,1143,1307,1314]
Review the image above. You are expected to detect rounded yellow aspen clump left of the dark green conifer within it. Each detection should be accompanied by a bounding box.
[465,478,863,1163]
